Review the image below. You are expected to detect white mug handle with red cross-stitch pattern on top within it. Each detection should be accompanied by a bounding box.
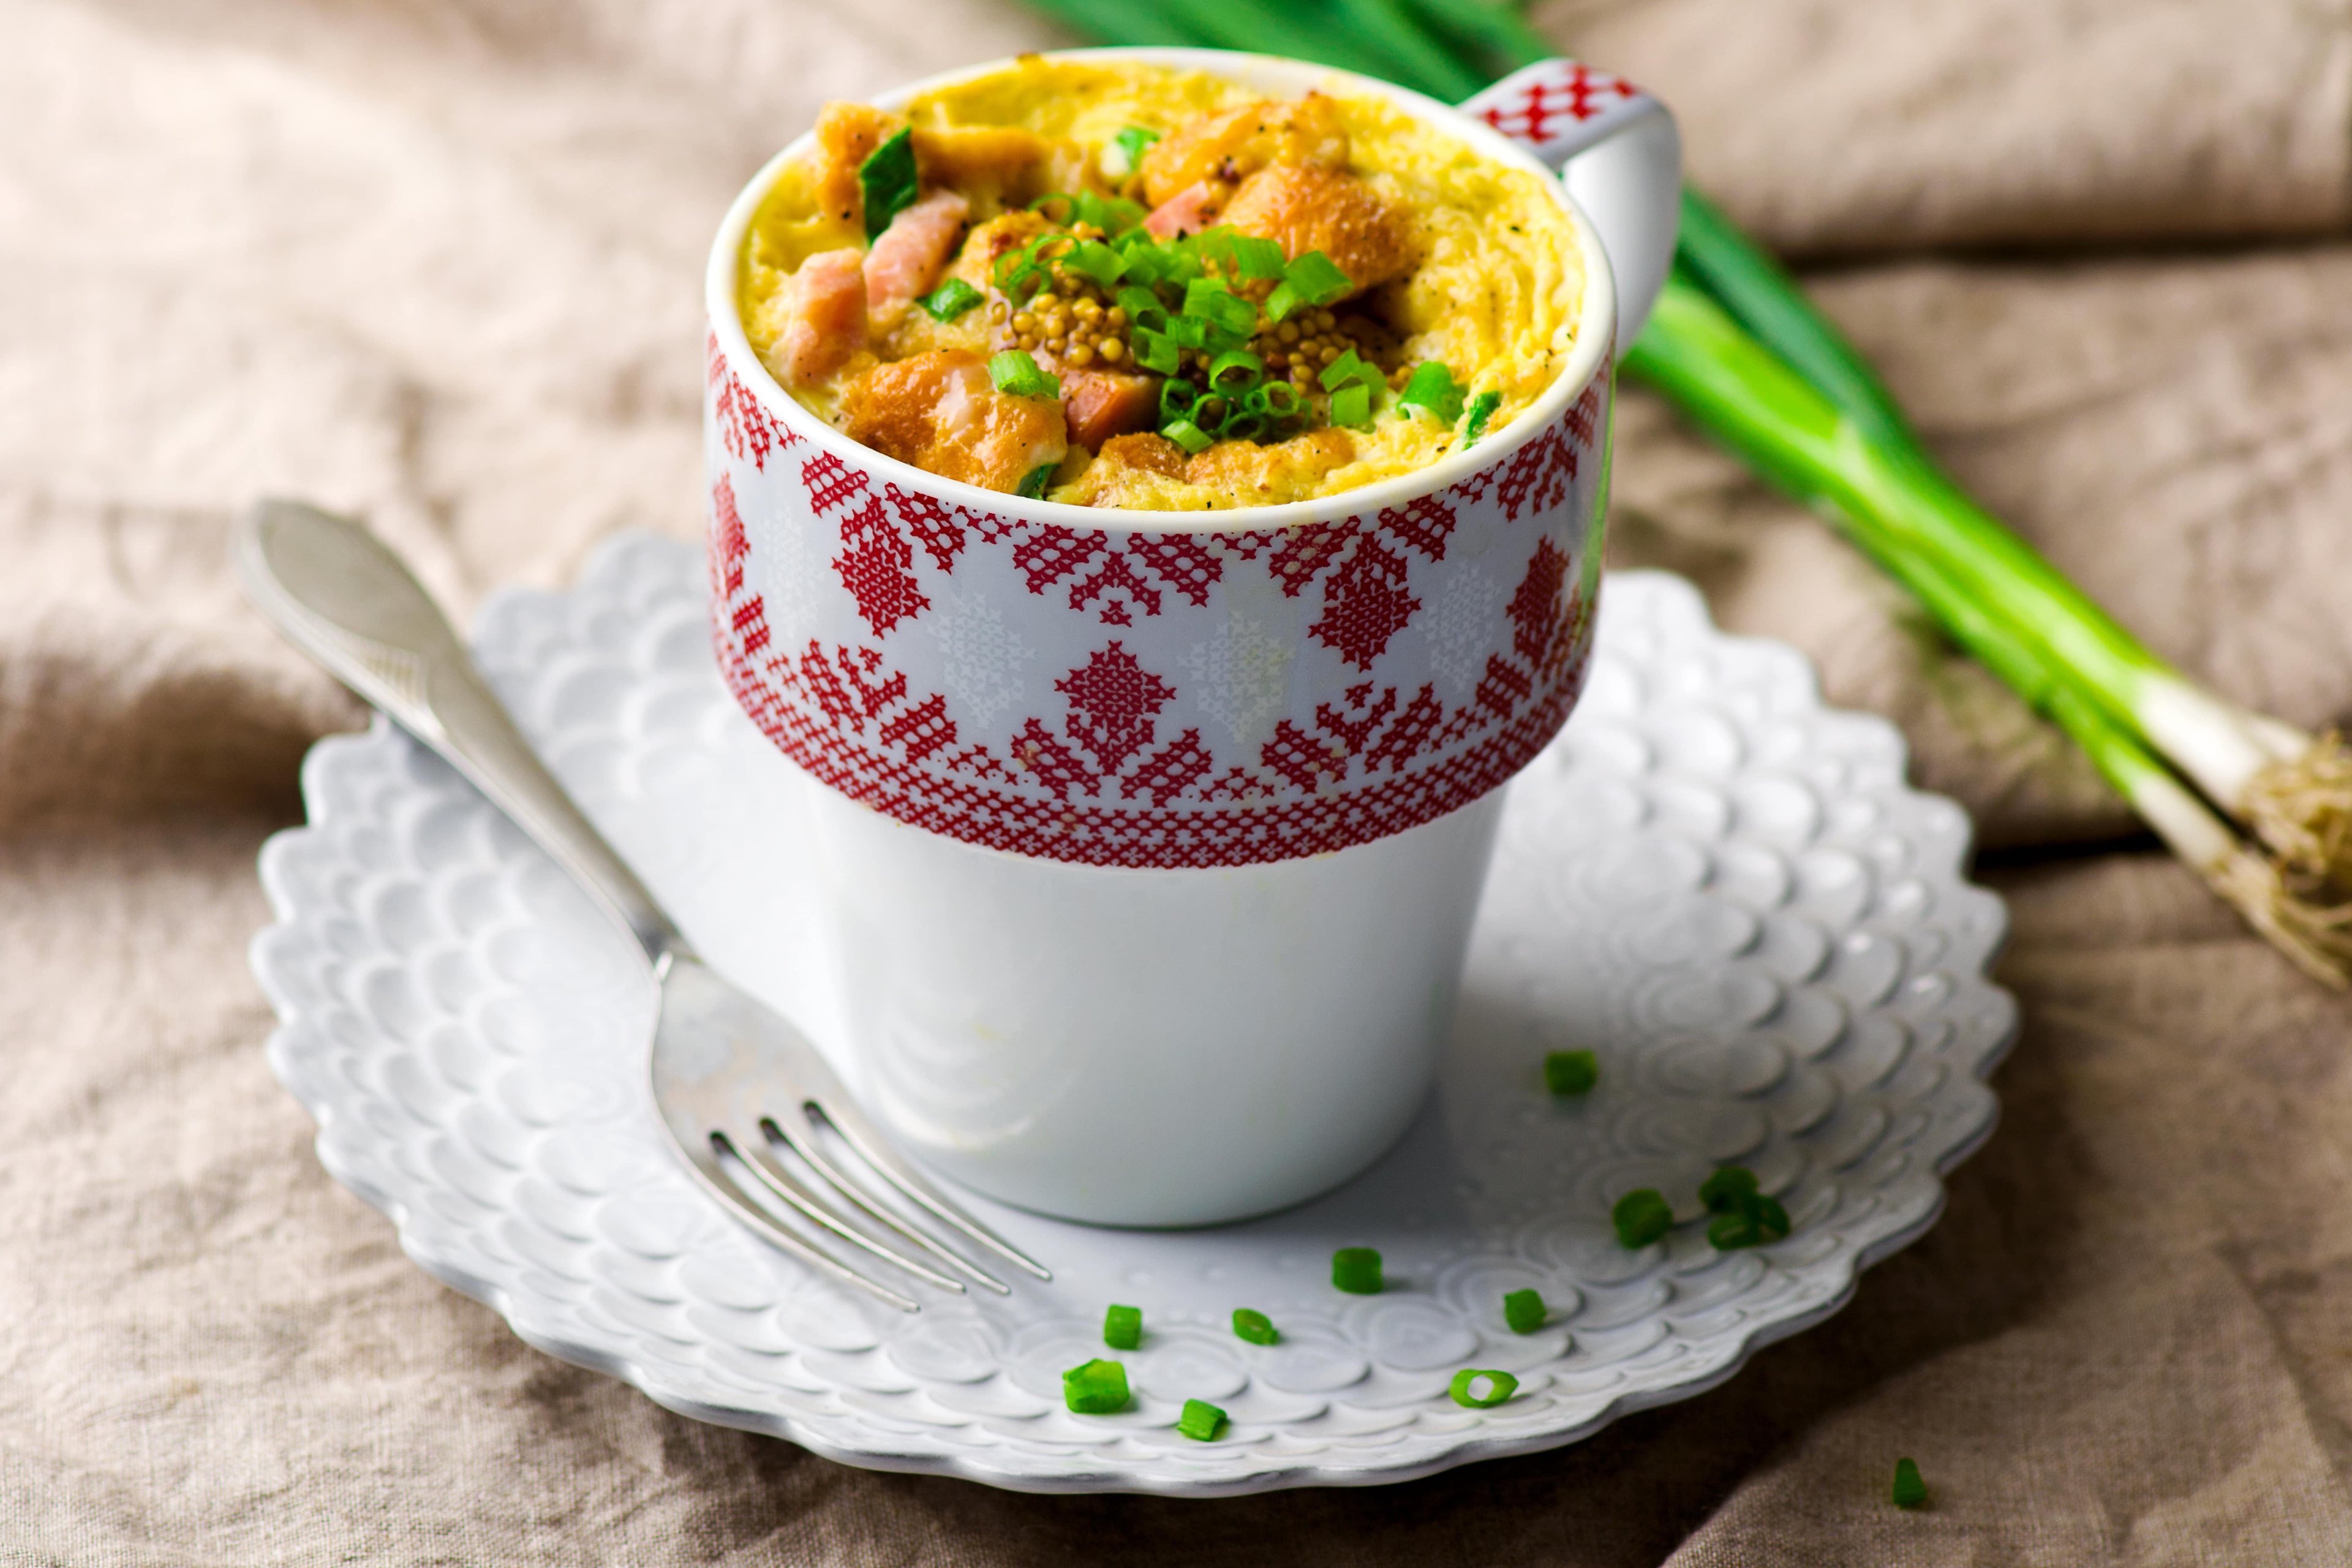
[1461,59,1682,357]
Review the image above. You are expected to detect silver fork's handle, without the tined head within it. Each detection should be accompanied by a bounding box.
[235,501,689,968]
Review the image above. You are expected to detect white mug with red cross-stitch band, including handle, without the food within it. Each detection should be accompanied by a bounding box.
[706,50,1679,1225]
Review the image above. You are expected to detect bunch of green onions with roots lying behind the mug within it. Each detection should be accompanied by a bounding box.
[1033,0,2352,985]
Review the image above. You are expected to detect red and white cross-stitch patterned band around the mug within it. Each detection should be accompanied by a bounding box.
[706,334,1607,867]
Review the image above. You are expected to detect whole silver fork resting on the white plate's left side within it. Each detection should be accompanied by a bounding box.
[235,501,1051,1312]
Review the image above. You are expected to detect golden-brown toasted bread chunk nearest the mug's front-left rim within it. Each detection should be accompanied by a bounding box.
[842,348,1070,491]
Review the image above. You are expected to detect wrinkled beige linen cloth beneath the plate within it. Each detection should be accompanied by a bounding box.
[13,0,2352,1566]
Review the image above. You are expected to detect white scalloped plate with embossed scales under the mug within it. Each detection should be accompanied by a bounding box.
[254,536,2016,1495]
